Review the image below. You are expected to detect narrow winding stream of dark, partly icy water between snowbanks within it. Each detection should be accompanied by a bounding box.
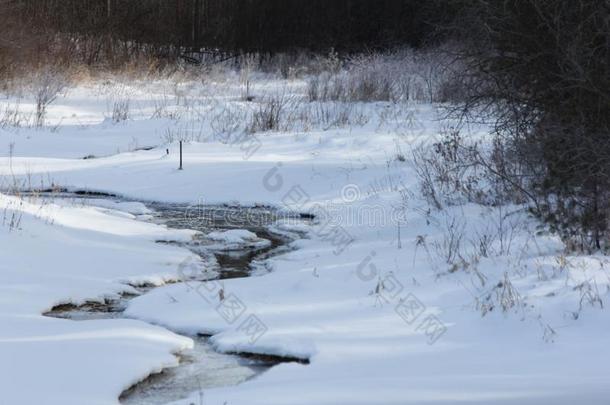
[45,193,307,405]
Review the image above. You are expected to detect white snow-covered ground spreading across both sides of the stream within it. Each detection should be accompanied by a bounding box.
[0,78,610,405]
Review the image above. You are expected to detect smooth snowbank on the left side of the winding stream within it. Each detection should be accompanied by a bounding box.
[0,196,192,404]
